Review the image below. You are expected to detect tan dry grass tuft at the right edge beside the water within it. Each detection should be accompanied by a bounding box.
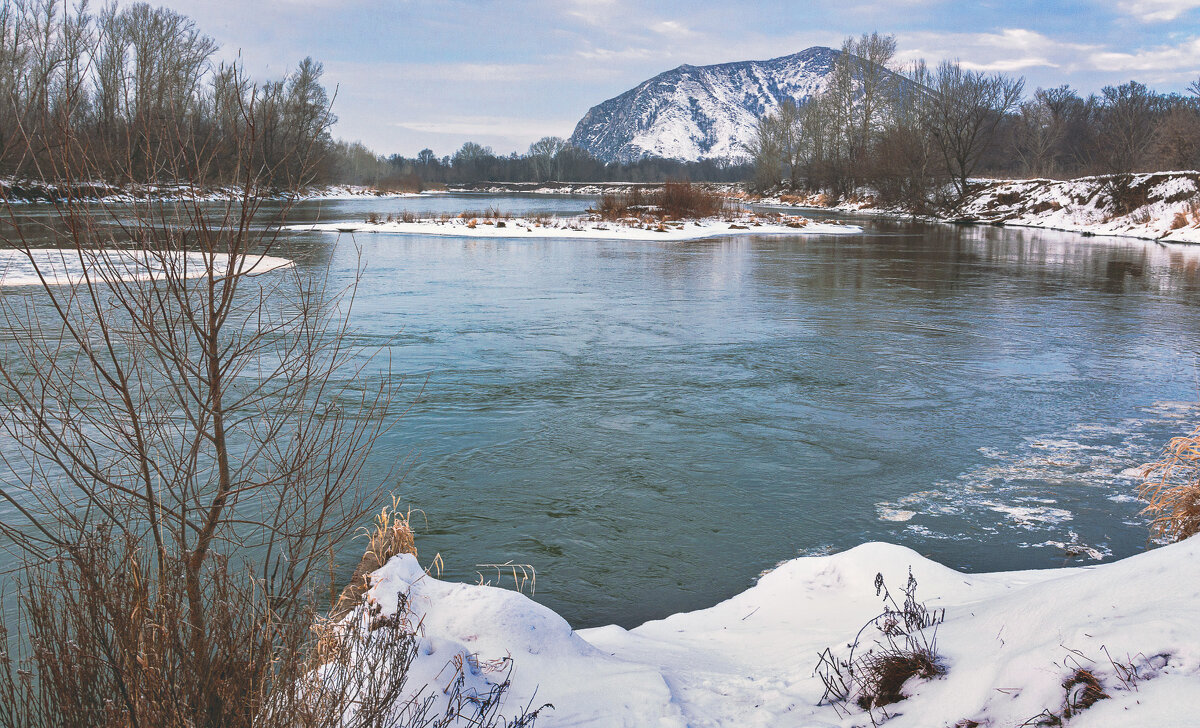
[1138,428,1200,541]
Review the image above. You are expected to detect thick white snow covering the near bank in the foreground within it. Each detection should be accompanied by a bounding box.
[368,537,1200,728]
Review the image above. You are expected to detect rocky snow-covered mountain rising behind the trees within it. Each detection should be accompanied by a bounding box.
[571,47,840,162]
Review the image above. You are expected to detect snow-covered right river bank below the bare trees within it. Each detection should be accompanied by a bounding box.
[758,172,1200,243]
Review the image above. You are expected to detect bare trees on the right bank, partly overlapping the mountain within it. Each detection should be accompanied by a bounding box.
[749,34,1200,211]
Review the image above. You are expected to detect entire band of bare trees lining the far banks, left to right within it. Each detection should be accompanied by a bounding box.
[7,0,1200,196]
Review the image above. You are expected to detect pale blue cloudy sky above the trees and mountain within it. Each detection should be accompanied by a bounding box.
[152,0,1200,156]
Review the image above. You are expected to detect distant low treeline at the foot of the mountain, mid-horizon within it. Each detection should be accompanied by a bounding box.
[335,137,754,189]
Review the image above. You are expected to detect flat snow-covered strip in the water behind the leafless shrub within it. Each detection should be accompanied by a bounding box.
[0,248,293,287]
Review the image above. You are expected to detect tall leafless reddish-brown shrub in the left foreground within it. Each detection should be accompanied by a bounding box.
[0,39,536,728]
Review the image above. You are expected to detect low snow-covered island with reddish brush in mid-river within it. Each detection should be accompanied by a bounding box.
[287,216,863,242]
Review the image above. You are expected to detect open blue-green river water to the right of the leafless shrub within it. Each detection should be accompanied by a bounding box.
[2,195,1200,627]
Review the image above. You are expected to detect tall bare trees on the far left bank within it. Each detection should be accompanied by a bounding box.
[0,0,335,186]
